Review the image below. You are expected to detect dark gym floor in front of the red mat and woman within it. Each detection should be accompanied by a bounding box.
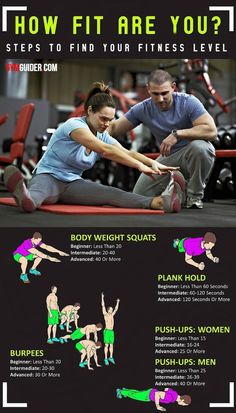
[0,191,236,229]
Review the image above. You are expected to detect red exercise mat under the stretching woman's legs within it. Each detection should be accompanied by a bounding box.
[0,198,164,215]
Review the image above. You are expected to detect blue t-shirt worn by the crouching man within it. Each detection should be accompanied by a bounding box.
[125,92,207,153]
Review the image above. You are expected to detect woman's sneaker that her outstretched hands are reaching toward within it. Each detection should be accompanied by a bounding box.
[161,171,185,212]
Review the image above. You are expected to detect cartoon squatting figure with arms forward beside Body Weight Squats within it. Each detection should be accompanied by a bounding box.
[13,232,69,284]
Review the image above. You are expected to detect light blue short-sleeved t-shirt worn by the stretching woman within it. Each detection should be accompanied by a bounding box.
[35,117,118,182]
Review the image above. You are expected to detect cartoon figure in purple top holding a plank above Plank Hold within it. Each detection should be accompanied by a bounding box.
[173,232,219,271]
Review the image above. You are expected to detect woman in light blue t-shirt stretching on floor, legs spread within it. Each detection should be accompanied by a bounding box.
[4,82,185,212]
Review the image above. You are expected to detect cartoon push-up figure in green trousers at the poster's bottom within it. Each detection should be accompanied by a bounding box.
[116,388,191,412]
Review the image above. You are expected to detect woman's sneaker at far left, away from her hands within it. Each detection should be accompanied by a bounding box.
[4,165,36,212]
